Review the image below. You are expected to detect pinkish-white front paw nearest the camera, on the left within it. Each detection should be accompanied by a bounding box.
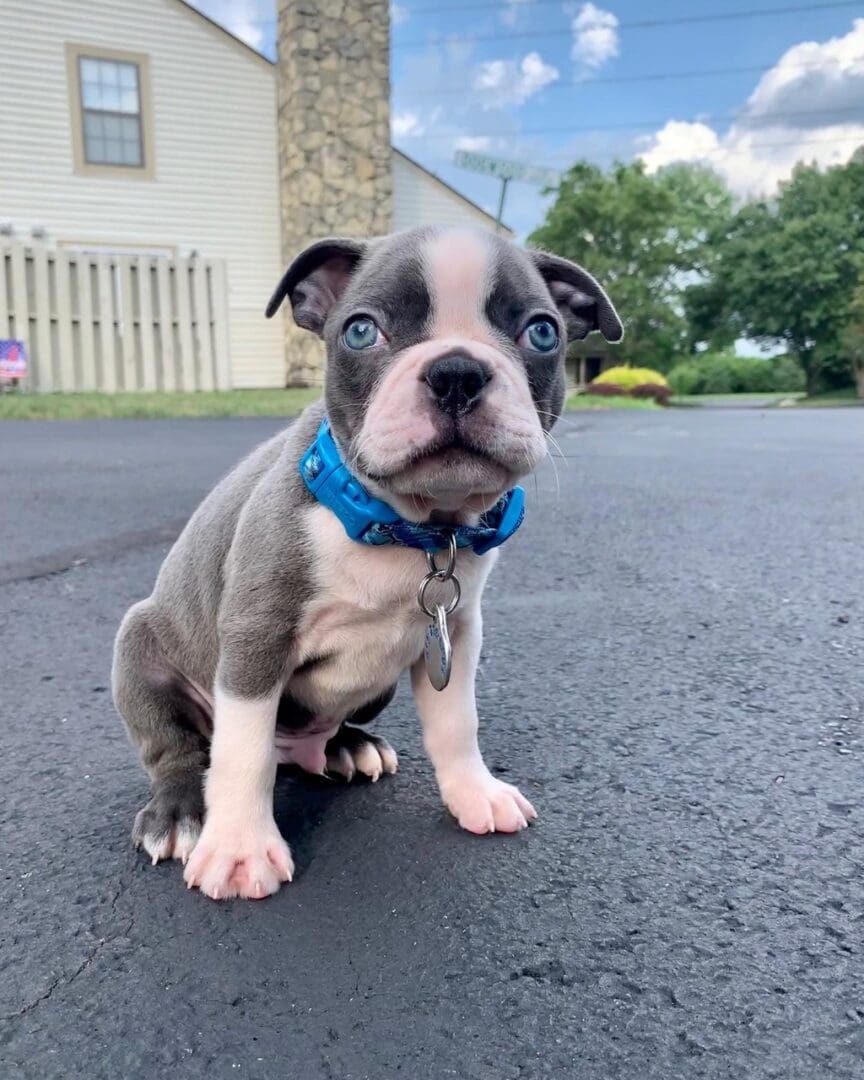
[184,818,294,900]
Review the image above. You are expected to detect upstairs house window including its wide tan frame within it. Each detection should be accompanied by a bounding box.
[66,45,153,179]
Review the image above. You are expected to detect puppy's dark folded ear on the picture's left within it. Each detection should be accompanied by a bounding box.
[265,237,367,337]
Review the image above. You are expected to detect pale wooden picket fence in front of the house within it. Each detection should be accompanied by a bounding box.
[0,244,231,393]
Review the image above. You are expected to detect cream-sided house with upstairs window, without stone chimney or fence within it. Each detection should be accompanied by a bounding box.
[0,0,509,388]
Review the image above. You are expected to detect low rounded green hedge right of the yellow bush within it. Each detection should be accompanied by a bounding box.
[669,353,805,394]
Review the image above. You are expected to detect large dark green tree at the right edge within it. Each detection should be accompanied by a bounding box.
[686,159,864,393]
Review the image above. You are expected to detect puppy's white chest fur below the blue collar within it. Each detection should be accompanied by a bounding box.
[288,507,495,719]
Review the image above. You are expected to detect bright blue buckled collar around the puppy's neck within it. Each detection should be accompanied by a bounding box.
[300,417,525,555]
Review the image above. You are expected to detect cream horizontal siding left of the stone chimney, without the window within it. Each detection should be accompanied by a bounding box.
[0,0,284,387]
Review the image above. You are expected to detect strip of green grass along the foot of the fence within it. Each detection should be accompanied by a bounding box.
[0,389,321,420]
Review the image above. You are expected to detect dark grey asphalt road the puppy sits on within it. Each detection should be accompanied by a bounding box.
[0,409,864,1080]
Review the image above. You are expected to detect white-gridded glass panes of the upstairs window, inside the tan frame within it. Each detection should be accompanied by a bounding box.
[78,56,144,168]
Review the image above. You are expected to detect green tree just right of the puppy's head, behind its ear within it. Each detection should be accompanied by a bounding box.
[529,162,732,370]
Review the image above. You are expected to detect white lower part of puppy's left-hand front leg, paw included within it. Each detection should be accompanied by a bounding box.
[185,681,294,900]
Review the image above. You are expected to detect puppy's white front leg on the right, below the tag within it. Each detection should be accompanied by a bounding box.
[411,608,537,833]
